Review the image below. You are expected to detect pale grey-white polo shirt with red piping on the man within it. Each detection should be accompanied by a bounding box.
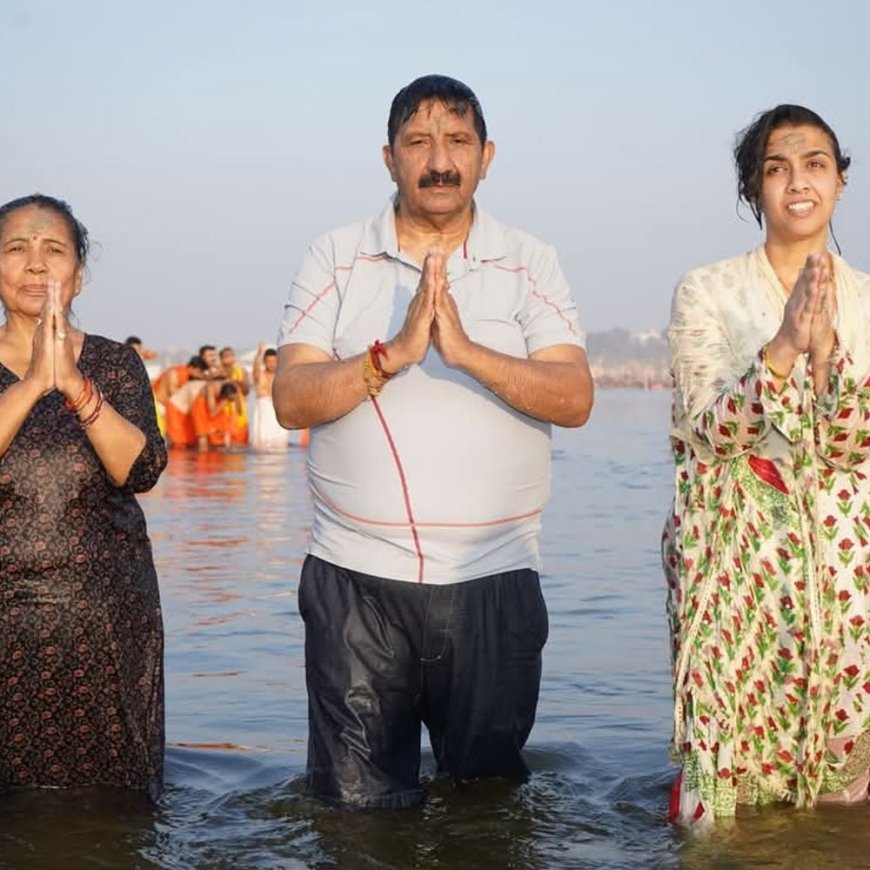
[278,200,584,583]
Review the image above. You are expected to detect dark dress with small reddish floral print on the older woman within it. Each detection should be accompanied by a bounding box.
[0,335,166,798]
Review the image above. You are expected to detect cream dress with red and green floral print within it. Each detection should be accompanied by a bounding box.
[663,248,870,824]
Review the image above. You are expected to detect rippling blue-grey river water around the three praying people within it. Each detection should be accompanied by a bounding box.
[0,390,870,870]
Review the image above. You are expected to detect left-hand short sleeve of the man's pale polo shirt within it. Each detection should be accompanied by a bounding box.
[278,235,341,356]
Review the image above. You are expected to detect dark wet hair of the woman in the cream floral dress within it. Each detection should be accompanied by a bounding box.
[734,103,852,227]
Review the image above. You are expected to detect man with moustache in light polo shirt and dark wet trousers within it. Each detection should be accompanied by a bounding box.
[273,75,593,807]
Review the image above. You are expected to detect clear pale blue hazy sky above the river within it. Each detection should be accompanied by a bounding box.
[0,0,870,354]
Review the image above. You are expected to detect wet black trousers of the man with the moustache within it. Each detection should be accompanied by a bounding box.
[299,556,548,807]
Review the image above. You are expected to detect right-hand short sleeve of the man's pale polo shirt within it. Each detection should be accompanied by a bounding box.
[519,245,586,354]
